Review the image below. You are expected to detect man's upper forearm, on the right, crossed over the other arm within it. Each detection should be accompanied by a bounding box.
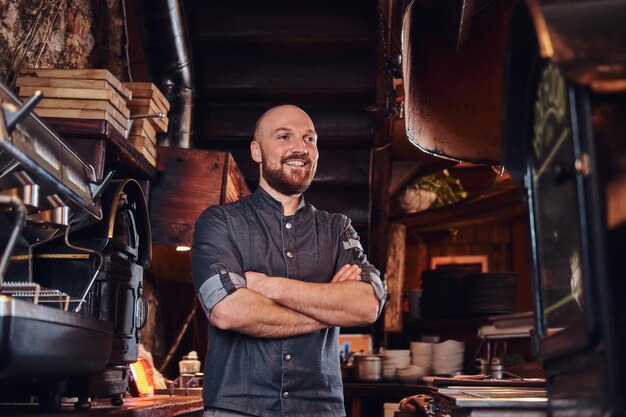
[254,277,379,327]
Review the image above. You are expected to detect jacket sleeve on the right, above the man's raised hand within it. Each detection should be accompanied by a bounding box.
[336,217,387,316]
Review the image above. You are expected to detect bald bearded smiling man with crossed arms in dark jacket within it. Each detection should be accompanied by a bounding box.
[192,105,385,417]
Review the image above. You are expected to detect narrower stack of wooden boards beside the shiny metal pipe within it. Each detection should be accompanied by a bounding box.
[124,82,170,166]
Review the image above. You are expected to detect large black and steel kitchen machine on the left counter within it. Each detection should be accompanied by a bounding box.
[0,79,151,410]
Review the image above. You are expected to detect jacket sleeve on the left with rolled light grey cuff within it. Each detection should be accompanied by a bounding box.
[191,206,246,317]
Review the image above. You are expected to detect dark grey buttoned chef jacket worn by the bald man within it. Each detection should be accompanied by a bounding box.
[192,187,385,417]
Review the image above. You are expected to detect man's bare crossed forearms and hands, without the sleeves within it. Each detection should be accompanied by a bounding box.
[210,265,379,338]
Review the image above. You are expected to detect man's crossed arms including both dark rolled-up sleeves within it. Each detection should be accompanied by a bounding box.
[192,207,384,338]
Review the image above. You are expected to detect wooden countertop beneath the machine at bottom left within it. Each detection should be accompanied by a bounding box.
[0,395,204,417]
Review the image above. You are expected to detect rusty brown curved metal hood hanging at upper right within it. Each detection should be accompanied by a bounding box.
[403,1,508,165]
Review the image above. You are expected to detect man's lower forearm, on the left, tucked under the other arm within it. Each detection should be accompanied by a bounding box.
[210,288,331,338]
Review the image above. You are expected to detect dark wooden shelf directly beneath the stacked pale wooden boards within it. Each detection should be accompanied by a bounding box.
[45,117,157,180]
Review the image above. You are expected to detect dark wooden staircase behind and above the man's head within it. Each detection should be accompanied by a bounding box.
[184,0,379,234]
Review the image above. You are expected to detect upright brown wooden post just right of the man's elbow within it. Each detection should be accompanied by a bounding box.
[385,223,406,333]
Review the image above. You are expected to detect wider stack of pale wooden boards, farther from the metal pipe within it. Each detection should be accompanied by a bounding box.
[16,68,132,137]
